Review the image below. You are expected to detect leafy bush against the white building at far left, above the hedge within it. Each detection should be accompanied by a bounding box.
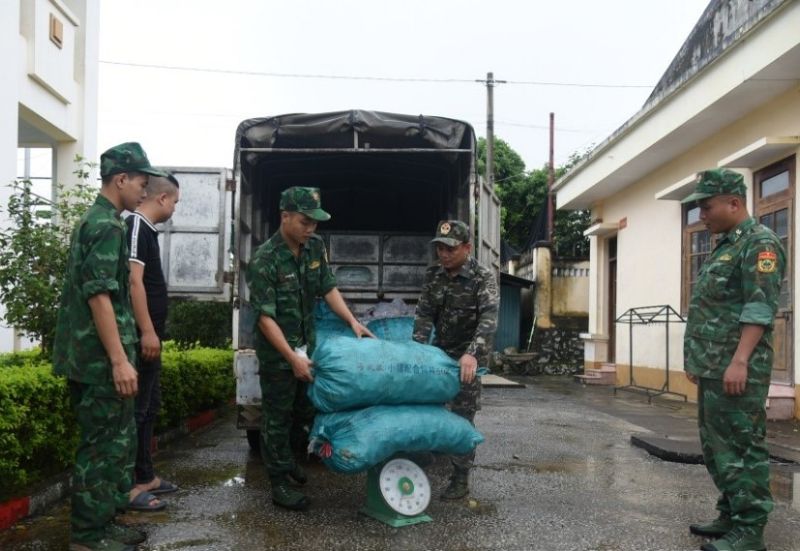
[0,156,96,354]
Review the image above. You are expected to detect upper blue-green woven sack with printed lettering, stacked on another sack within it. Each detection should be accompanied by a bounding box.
[308,336,460,412]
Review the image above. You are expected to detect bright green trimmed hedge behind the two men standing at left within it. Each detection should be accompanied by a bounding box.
[0,343,235,501]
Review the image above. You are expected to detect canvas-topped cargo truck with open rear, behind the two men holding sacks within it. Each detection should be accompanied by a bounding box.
[158,110,500,447]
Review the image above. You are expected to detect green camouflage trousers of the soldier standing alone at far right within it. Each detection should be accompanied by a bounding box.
[697,378,774,527]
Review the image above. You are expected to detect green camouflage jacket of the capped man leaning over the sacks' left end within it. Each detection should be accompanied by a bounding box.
[246,231,336,369]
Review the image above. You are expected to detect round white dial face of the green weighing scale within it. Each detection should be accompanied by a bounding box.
[380,459,431,516]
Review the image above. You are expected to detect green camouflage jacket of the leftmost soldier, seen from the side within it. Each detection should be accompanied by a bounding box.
[53,195,138,384]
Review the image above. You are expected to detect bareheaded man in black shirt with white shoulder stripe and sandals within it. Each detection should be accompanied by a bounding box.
[127,174,180,511]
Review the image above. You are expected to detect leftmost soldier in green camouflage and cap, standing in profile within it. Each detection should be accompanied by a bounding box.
[53,143,164,550]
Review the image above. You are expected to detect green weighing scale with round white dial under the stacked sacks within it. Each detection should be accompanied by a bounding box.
[359,459,433,528]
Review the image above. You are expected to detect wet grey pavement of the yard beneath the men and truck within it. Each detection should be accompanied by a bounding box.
[0,377,800,551]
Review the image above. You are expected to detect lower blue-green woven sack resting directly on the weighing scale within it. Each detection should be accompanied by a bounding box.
[309,405,483,473]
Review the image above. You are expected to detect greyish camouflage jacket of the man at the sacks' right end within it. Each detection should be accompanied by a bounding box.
[413,257,499,366]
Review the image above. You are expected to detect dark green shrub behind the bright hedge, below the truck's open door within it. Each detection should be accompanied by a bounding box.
[167,299,233,348]
